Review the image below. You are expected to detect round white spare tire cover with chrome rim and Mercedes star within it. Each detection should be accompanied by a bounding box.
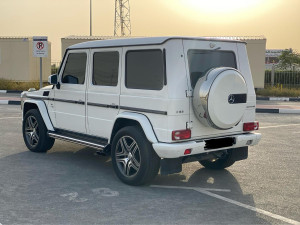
[193,67,248,130]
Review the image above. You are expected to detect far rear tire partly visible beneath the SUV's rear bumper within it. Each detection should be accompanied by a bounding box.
[199,150,235,170]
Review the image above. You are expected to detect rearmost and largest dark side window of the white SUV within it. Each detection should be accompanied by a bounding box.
[125,49,164,90]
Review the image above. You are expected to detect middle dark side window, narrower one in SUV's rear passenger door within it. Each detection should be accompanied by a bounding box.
[93,52,119,86]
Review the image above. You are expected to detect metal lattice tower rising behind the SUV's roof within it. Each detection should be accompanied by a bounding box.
[114,0,131,36]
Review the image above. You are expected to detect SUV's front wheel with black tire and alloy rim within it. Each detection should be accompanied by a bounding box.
[22,109,55,152]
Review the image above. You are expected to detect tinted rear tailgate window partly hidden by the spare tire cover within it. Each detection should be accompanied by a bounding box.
[188,50,236,88]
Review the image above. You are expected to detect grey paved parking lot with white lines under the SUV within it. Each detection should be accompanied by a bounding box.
[0,105,300,225]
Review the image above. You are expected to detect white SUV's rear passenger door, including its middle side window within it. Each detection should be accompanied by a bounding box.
[87,48,122,139]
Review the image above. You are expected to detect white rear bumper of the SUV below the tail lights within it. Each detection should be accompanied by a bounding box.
[152,133,261,158]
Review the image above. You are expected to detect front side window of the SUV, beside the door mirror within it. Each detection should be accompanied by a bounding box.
[61,53,86,84]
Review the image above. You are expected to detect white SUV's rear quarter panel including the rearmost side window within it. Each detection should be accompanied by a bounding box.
[120,45,168,139]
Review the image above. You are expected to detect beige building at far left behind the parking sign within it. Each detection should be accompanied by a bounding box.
[0,37,51,81]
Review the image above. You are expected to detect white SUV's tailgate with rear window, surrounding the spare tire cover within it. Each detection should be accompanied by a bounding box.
[183,40,241,139]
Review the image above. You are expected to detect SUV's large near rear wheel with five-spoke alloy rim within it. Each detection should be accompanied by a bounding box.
[111,126,160,185]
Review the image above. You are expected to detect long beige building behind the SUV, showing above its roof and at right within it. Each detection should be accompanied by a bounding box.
[61,36,267,88]
